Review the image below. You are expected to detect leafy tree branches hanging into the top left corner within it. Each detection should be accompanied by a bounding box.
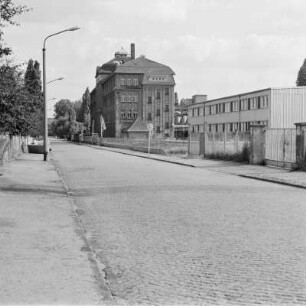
[0,0,30,58]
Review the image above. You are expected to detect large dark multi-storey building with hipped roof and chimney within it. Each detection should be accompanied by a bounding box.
[91,44,175,137]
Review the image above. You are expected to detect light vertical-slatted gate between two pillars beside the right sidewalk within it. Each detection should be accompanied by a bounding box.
[265,129,296,168]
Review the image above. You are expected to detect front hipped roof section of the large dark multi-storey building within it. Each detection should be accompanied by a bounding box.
[115,56,175,75]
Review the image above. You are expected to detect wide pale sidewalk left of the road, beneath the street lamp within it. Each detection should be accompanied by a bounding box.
[0,154,110,305]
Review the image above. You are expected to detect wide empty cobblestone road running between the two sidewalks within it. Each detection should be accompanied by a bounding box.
[54,145,306,305]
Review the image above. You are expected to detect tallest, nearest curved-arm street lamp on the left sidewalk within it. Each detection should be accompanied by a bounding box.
[42,27,80,161]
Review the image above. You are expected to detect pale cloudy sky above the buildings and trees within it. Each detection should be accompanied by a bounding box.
[4,0,306,117]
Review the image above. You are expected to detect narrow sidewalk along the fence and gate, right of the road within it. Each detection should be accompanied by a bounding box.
[83,144,306,188]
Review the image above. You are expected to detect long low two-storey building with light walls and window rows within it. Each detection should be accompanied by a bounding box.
[188,87,306,133]
